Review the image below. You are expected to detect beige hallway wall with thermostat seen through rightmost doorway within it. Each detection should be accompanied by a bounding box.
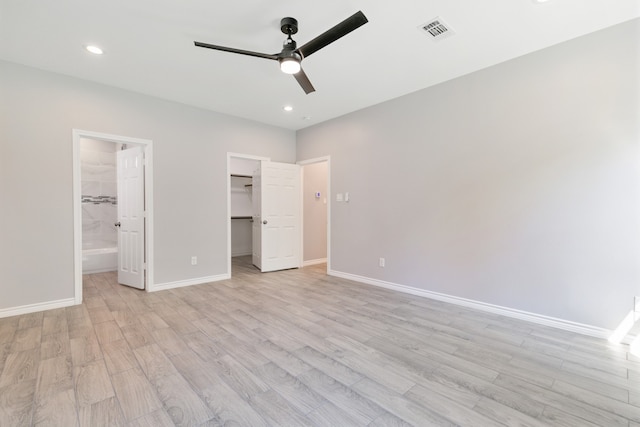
[302,161,329,261]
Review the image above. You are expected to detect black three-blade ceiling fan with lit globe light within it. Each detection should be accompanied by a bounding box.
[193,11,369,94]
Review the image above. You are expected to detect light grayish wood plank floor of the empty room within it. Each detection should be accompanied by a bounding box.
[0,258,640,427]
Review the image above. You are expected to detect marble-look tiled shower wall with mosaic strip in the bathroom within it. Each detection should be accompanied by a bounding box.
[80,138,120,249]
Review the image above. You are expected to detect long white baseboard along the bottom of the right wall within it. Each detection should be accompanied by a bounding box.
[327,270,613,339]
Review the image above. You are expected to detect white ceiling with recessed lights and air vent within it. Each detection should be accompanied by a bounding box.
[0,0,640,129]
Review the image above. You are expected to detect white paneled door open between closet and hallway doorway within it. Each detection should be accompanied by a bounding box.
[253,161,301,272]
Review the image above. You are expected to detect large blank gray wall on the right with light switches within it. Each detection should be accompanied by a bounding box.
[297,20,640,329]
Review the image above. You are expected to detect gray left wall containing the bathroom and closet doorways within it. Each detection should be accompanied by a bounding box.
[0,62,295,309]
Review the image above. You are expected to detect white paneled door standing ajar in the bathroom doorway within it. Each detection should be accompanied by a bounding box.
[116,147,144,289]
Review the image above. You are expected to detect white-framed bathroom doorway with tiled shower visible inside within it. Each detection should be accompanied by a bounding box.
[73,130,153,304]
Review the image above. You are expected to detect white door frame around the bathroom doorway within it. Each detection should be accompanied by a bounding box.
[72,129,154,304]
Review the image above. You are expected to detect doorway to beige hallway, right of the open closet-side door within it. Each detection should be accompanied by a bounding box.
[298,156,331,270]
